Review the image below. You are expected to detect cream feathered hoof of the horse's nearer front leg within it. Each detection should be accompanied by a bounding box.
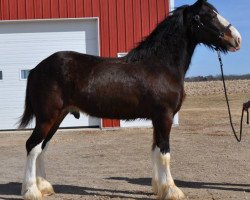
[158,185,186,200]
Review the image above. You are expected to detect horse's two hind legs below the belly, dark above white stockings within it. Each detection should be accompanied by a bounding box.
[22,113,66,200]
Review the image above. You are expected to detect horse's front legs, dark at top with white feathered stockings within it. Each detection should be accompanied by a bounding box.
[152,113,185,200]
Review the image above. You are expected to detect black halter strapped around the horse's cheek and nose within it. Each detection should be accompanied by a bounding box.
[193,15,232,39]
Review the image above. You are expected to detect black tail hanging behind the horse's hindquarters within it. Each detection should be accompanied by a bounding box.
[19,71,34,128]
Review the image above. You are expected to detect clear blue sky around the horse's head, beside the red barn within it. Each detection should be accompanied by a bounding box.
[174,0,250,77]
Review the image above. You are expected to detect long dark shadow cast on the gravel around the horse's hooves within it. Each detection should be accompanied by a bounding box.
[0,177,250,200]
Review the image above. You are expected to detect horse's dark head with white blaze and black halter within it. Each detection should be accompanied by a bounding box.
[189,0,242,52]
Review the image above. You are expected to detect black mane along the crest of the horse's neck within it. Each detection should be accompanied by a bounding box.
[124,5,189,62]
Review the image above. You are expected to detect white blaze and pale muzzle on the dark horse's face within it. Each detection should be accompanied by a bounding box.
[214,11,242,51]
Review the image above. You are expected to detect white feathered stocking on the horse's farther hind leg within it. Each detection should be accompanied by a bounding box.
[36,143,55,196]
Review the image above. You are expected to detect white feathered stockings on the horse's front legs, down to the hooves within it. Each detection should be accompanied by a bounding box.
[152,147,185,200]
